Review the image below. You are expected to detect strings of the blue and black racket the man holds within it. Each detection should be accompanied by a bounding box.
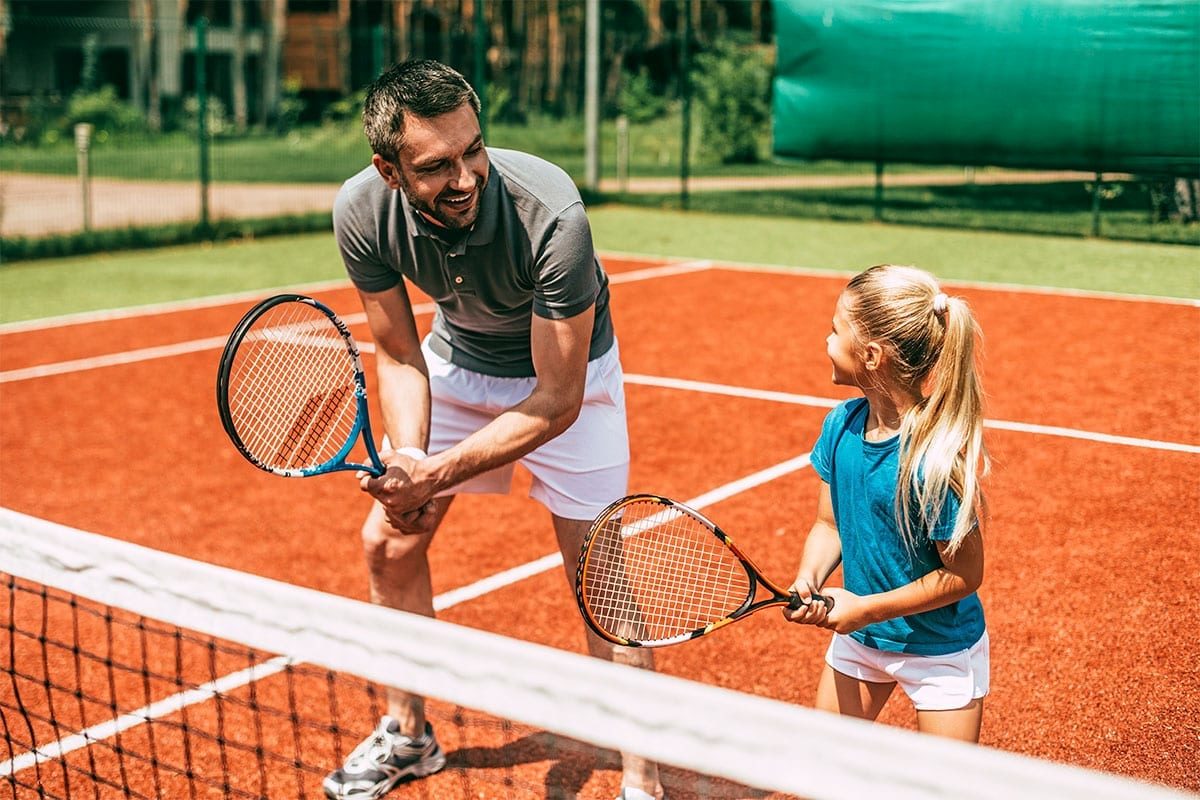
[229,302,358,469]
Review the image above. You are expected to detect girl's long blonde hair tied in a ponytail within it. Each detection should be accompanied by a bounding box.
[845,264,989,552]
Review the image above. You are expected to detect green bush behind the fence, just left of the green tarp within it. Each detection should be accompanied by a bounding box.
[692,37,772,164]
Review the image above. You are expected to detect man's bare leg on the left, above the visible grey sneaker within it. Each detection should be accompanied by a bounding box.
[362,497,454,738]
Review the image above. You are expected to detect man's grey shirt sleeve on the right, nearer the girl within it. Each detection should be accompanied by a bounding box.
[533,203,600,319]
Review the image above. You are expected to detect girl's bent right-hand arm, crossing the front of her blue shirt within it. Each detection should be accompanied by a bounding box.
[822,528,983,633]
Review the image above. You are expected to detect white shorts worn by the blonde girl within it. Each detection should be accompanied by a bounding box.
[826,631,990,711]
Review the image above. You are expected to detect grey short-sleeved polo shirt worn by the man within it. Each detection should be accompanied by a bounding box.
[334,148,613,378]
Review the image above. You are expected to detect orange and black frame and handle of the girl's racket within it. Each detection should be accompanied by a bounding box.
[575,493,833,648]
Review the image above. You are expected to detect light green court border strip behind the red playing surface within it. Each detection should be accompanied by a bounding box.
[0,205,1200,321]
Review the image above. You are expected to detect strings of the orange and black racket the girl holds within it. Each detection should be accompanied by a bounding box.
[582,500,754,642]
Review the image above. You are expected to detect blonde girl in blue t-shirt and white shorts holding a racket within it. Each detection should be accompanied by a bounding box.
[785,265,989,741]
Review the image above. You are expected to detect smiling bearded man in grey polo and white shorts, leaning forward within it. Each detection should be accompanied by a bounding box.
[325,60,662,800]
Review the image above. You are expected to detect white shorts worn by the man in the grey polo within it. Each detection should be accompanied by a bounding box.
[421,339,629,519]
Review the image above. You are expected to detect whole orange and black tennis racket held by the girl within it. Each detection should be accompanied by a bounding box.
[575,494,833,648]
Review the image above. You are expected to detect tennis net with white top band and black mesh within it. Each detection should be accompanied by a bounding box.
[0,509,1184,800]
